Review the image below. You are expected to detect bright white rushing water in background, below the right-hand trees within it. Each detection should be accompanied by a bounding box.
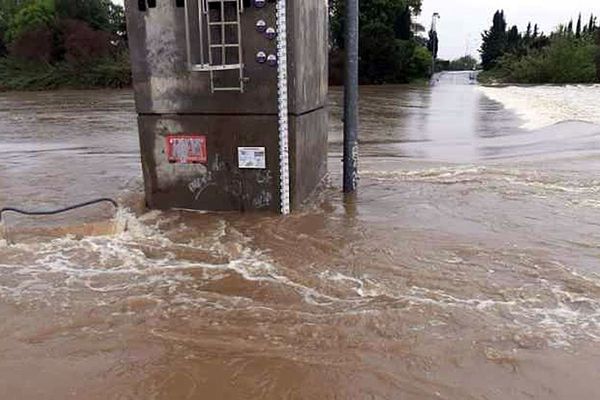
[478,85,600,130]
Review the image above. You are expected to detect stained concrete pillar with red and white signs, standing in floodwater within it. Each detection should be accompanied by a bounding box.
[126,0,328,211]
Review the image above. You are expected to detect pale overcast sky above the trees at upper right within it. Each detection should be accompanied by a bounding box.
[418,0,600,59]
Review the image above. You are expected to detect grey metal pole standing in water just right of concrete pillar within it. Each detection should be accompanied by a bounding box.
[344,0,359,193]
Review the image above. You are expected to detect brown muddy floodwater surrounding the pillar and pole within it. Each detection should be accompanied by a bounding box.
[0,74,600,400]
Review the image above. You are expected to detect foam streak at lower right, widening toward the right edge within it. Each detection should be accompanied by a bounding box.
[320,265,600,347]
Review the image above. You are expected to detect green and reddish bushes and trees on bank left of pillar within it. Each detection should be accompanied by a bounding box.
[0,0,131,90]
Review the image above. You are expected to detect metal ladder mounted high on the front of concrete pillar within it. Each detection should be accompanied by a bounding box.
[185,0,244,93]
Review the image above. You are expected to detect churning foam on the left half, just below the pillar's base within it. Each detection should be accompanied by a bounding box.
[0,209,360,308]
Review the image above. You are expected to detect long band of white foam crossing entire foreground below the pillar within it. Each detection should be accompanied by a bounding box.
[0,206,600,346]
